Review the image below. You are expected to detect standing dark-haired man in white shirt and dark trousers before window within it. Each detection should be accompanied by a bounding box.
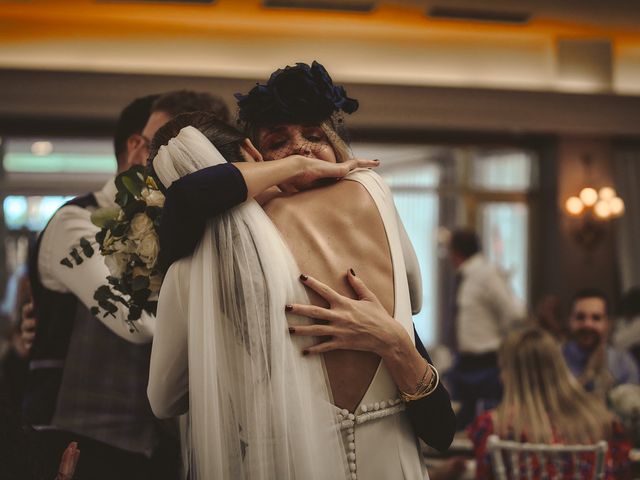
[449,230,525,430]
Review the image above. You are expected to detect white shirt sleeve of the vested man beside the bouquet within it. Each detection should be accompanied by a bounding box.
[38,180,155,343]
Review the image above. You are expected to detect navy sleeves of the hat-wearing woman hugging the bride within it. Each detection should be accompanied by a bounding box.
[160,163,456,451]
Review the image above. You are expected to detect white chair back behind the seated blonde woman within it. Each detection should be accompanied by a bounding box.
[488,435,608,480]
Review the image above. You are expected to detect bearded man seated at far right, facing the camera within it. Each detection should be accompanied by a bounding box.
[562,288,639,397]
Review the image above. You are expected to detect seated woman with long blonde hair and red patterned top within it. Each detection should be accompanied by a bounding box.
[468,327,631,480]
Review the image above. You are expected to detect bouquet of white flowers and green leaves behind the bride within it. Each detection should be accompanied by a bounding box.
[61,166,164,330]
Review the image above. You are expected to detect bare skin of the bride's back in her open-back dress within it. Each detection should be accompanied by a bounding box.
[264,180,394,411]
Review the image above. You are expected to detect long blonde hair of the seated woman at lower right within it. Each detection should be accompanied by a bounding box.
[496,327,612,443]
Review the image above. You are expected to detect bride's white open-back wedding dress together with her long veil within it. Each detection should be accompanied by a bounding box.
[148,127,428,480]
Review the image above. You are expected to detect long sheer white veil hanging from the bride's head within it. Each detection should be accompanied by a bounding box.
[153,127,348,480]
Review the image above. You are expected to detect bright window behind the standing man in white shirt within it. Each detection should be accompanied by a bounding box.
[353,143,537,345]
